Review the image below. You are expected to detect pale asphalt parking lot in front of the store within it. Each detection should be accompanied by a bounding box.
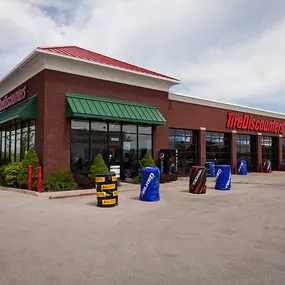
[0,172,285,285]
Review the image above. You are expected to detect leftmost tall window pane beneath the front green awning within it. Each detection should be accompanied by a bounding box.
[70,120,90,173]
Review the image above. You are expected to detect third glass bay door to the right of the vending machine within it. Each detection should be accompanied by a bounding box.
[237,134,257,172]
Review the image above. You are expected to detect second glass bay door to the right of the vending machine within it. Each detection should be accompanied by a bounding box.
[206,132,230,164]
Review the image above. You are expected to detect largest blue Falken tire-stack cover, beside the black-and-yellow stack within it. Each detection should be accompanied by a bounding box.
[140,167,160,202]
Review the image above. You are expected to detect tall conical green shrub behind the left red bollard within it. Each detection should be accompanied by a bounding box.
[17,148,39,188]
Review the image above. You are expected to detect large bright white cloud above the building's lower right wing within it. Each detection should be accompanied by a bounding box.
[178,19,285,102]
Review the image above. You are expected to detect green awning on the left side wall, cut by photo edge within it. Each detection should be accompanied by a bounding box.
[0,95,37,125]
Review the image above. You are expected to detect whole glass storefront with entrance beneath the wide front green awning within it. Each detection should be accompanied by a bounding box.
[71,120,152,179]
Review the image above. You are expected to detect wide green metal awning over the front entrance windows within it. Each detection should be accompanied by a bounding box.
[66,93,166,125]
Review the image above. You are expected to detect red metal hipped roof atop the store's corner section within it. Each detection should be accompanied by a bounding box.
[38,46,179,82]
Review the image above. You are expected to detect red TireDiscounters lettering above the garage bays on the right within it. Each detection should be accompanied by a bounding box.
[226,112,285,134]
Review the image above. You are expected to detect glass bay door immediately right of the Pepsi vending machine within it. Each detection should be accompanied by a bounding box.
[168,129,198,176]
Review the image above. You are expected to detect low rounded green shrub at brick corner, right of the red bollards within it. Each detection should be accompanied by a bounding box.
[43,168,78,192]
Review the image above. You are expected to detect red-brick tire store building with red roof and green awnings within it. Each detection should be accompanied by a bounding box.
[0,46,285,179]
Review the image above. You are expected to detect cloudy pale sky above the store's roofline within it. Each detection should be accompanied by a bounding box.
[0,0,285,113]
